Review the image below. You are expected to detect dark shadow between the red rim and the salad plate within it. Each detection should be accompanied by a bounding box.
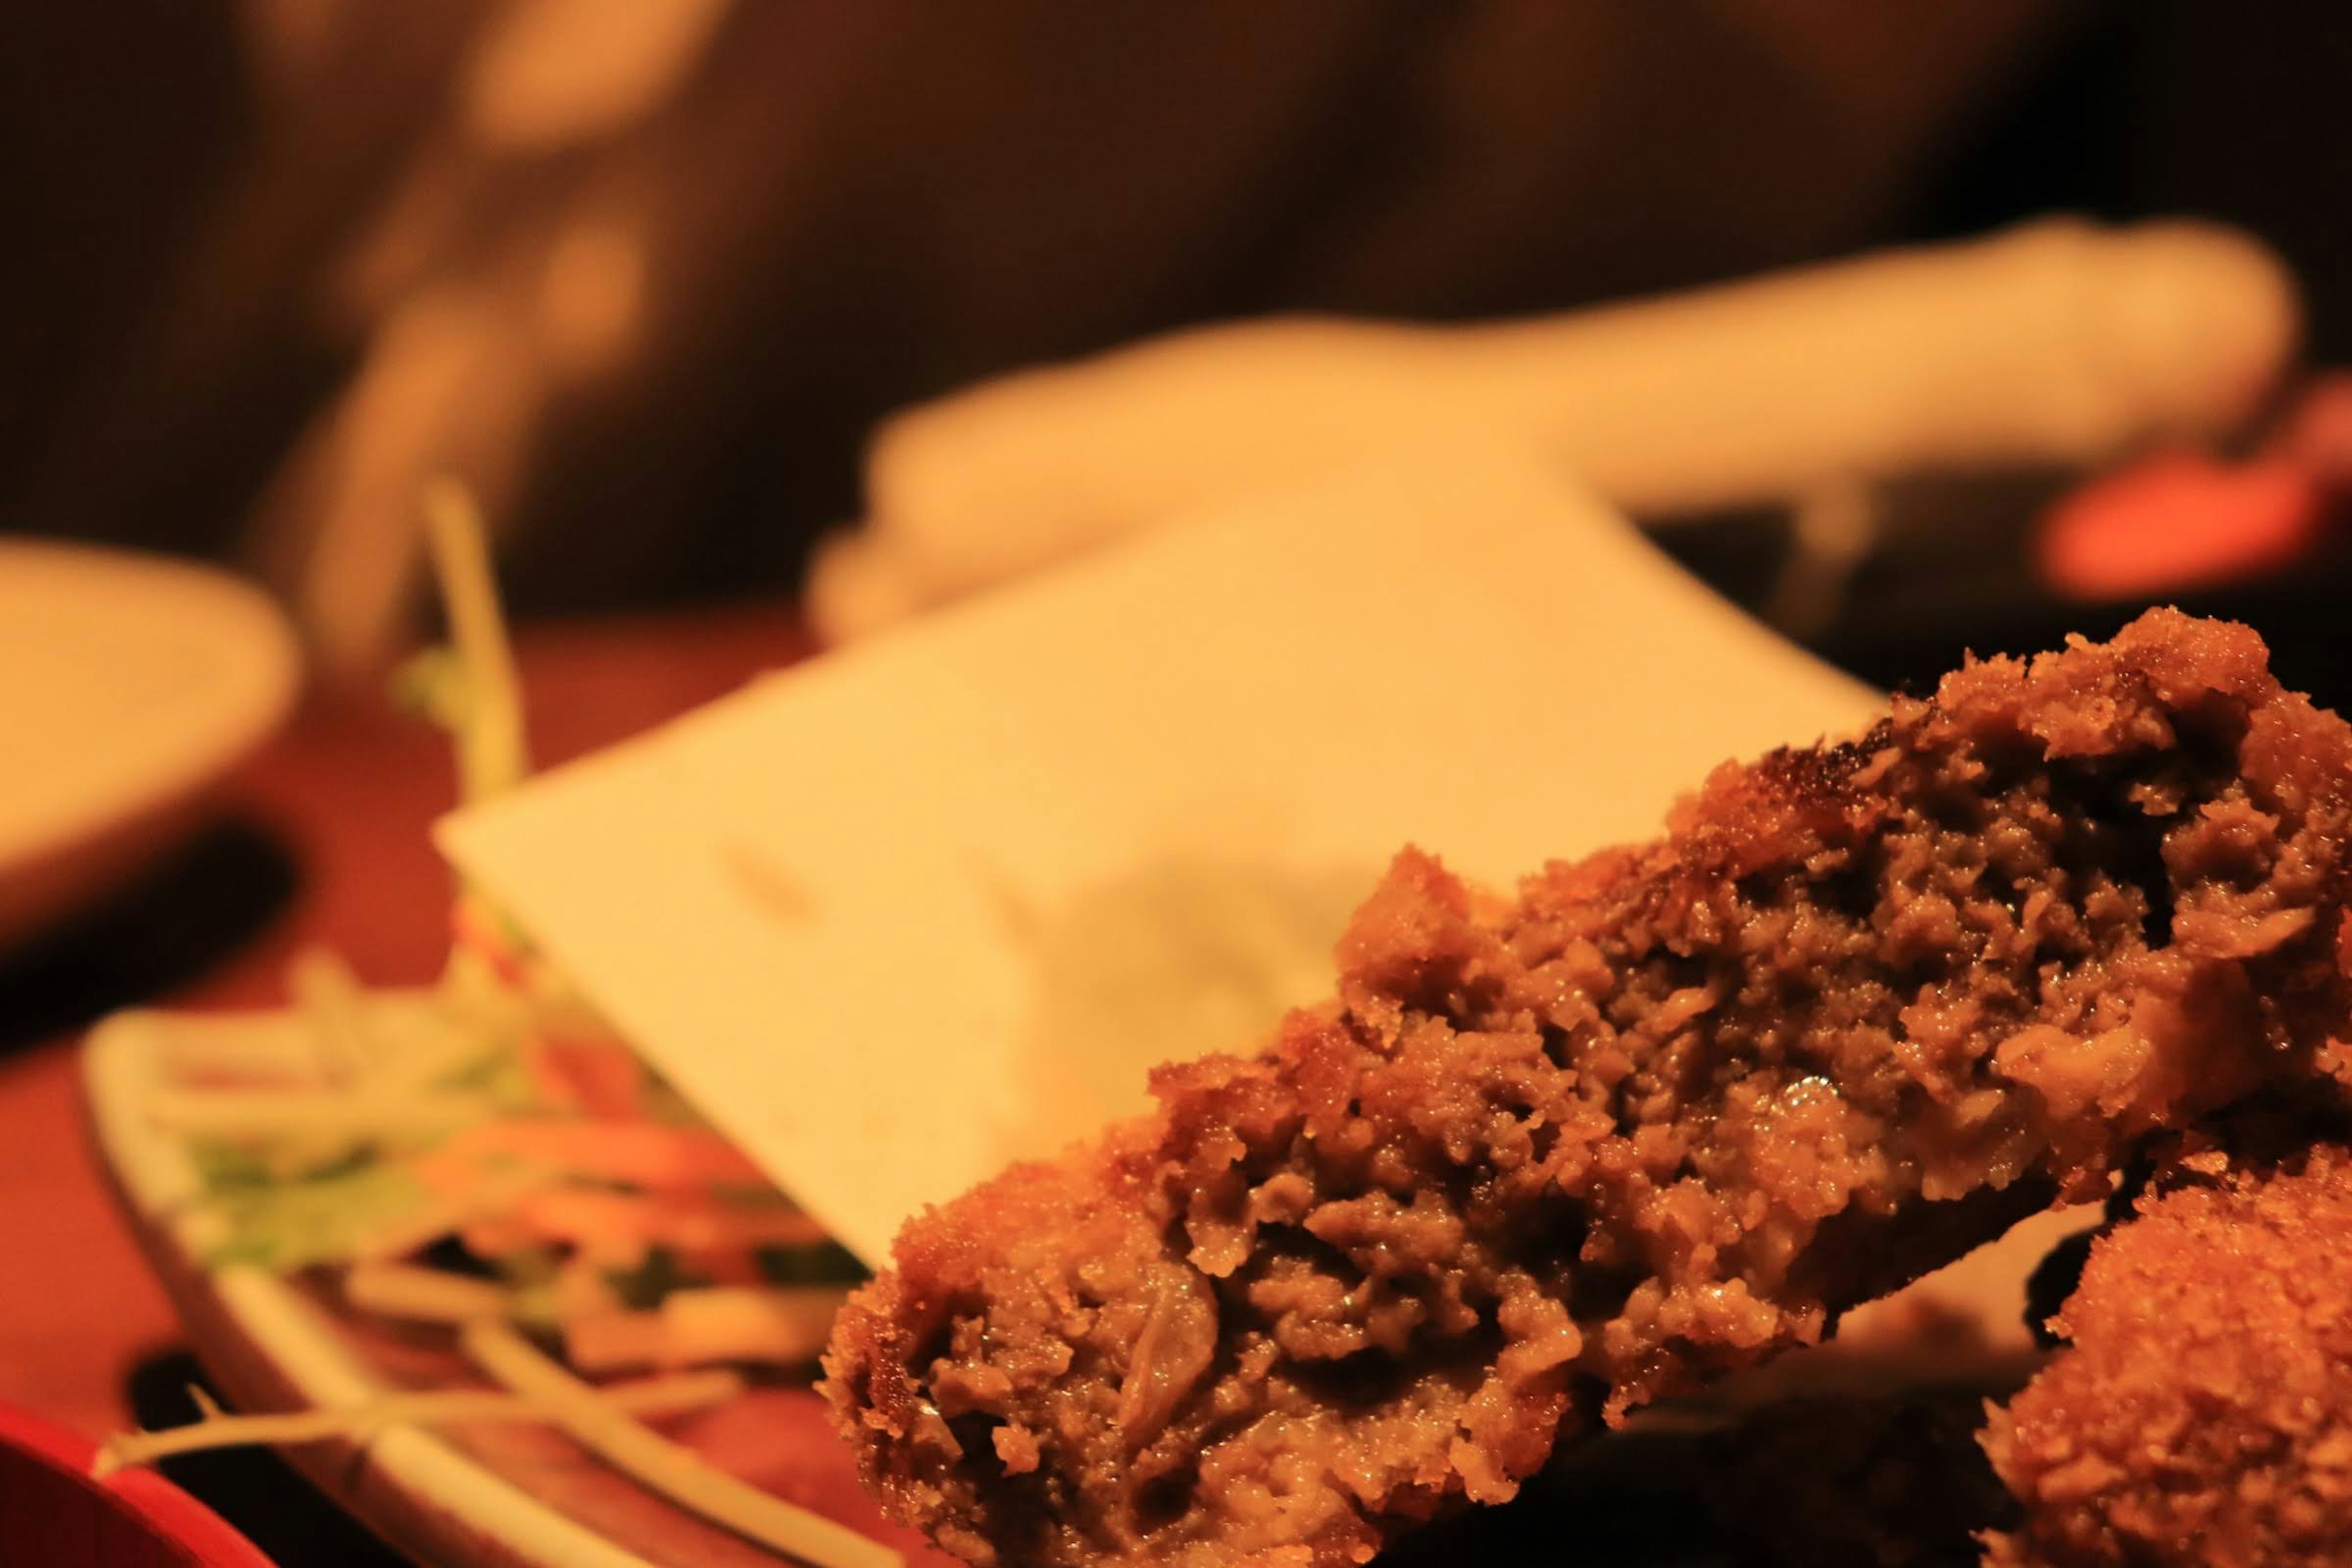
[125,1349,409,1568]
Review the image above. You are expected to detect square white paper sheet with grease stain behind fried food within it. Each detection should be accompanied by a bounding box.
[440,449,1872,1260]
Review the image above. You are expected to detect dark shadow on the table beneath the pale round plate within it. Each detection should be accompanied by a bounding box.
[0,818,299,1051]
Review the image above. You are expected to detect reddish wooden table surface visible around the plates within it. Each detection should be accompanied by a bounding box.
[0,606,809,1436]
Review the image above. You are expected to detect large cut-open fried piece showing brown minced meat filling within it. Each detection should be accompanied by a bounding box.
[826,611,2352,1568]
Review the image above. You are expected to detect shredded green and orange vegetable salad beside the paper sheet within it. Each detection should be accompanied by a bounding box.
[126,482,899,1568]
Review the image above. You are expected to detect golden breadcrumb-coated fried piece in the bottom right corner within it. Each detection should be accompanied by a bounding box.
[1985,1147,2352,1568]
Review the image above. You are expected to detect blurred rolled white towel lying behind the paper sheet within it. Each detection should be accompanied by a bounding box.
[809,219,2301,639]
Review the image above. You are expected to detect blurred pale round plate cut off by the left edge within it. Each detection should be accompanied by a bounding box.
[0,538,301,945]
